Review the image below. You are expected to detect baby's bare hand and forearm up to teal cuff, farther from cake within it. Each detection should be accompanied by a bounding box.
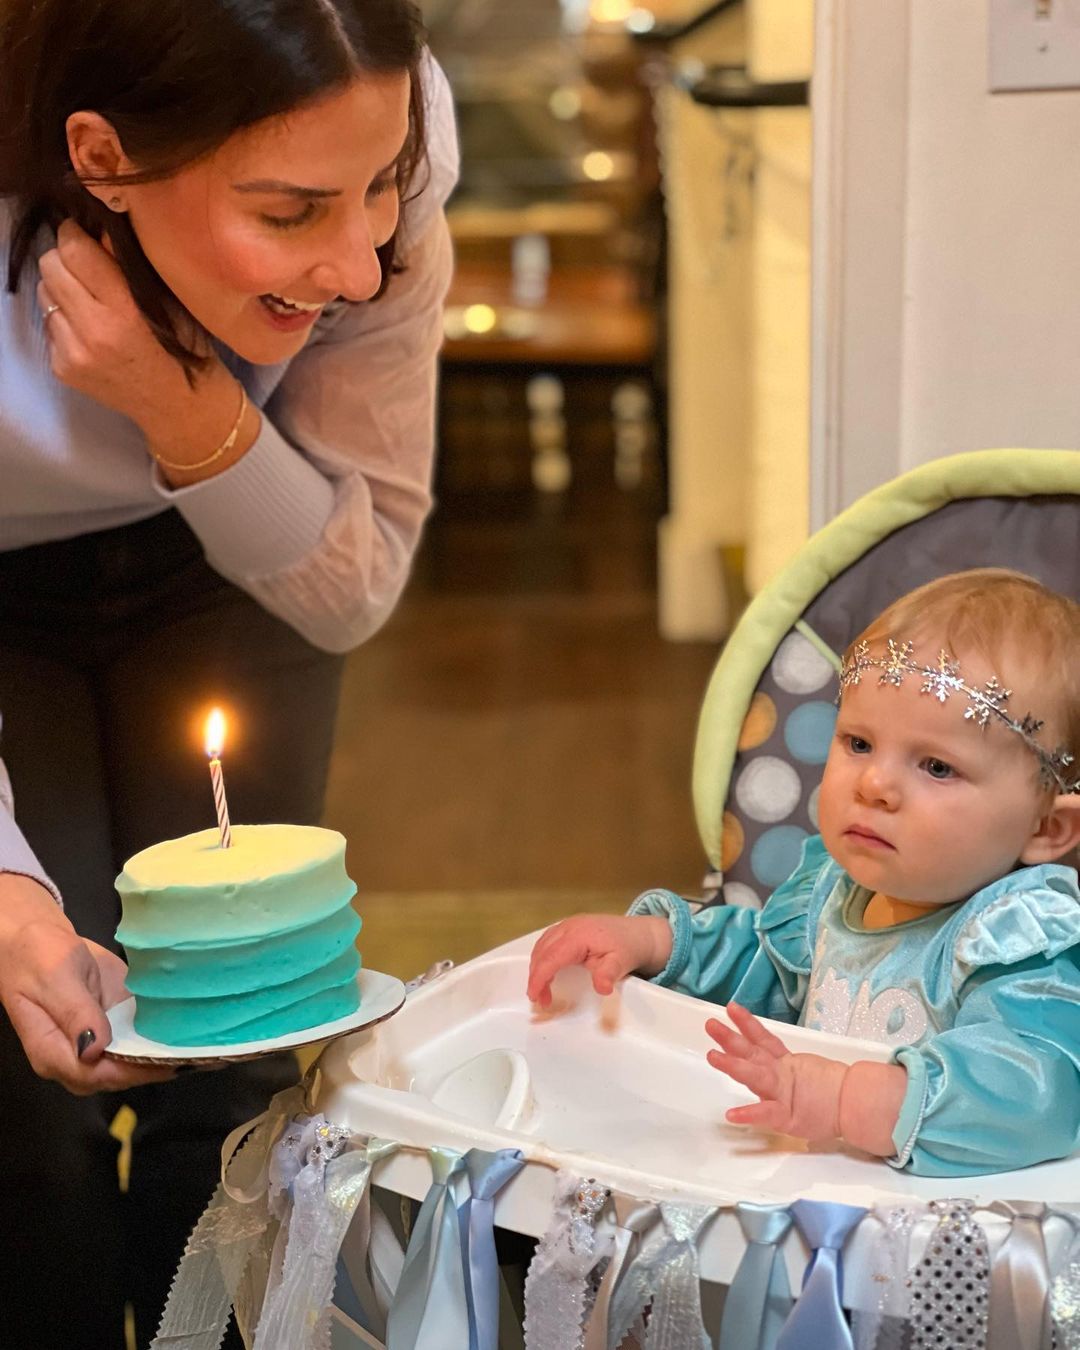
[705,1003,907,1158]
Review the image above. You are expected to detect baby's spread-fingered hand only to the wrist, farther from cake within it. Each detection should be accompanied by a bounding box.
[705,1003,848,1142]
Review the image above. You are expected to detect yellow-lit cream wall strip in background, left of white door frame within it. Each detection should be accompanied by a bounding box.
[659,0,813,639]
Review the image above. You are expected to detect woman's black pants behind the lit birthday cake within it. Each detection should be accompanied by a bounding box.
[0,512,342,1350]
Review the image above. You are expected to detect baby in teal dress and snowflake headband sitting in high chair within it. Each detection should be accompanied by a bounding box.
[528,568,1080,1176]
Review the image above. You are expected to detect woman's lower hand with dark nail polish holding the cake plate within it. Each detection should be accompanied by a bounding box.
[0,872,173,1096]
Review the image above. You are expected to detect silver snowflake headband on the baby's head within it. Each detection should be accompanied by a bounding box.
[840,637,1080,792]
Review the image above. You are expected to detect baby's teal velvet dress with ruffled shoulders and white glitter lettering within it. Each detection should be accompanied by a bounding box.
[630,837,1080,1176]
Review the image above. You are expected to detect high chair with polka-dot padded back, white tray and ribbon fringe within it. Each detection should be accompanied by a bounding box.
[155,450,1080,1350]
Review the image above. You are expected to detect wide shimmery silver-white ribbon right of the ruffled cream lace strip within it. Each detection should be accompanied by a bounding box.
[254,1115,397,1350]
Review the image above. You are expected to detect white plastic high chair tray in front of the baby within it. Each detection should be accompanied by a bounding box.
[316,934,1080,1281]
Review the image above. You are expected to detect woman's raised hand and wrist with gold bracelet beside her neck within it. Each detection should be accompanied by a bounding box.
[38,220,261,486]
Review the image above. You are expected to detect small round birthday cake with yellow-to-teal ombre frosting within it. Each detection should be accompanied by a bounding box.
[116,825,360,1046]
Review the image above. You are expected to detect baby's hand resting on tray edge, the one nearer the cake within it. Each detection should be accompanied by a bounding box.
[528,914,671,1008]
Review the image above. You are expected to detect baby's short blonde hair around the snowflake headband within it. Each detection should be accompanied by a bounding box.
[845,567,1080,777]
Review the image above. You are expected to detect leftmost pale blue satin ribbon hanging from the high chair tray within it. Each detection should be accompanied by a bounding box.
[386,1149,468,1350]
